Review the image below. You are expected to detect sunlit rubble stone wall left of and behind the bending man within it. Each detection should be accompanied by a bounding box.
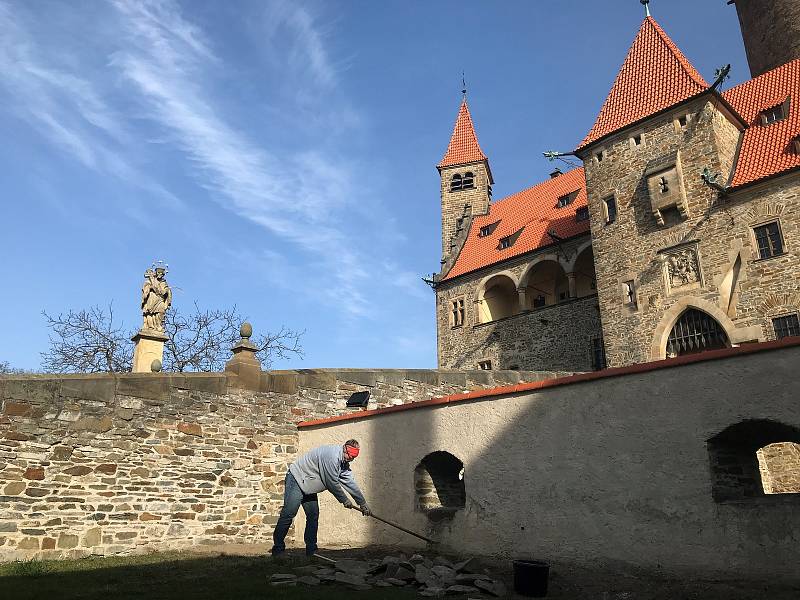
[0,370,552,560]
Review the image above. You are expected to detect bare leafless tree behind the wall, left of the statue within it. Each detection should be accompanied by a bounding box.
[42,304,133,373]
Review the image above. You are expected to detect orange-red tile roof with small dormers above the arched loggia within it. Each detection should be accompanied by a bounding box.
[443,168,589,280]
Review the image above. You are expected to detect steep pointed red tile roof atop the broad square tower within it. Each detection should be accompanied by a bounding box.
[578,17,708,150]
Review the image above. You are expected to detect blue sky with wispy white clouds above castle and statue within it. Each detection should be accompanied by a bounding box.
[0,0,749,369]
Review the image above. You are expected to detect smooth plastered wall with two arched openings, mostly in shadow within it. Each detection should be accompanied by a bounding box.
[301,347,800,583]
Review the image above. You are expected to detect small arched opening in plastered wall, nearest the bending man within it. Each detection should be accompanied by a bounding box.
[414,451,467,520]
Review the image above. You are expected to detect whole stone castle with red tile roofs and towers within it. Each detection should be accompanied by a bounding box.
[433,0,800,371]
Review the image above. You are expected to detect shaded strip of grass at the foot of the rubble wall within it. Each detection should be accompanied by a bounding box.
[0,552,418,600]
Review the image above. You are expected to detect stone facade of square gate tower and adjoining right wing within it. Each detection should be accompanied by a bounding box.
[585,98,800,366]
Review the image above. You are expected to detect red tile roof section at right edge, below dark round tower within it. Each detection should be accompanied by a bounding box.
[722,59,800,187]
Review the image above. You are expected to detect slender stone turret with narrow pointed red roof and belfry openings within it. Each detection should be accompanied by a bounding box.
[436,94,494,263]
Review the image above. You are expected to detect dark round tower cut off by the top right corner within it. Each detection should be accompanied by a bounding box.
[729,0,800,77]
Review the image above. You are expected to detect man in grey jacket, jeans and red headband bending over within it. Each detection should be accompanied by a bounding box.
[272,440,370,557]
